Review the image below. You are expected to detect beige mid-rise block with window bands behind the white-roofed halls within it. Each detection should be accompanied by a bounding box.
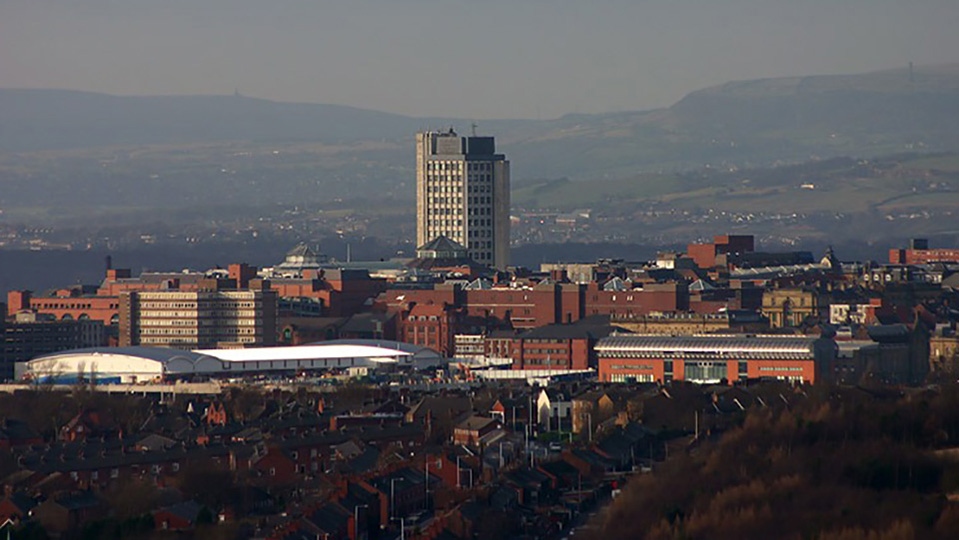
[119,283,276,349]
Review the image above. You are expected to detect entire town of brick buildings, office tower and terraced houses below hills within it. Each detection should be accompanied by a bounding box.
[0,129,959,540]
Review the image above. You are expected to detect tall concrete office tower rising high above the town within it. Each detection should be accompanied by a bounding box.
[416,129,509,270]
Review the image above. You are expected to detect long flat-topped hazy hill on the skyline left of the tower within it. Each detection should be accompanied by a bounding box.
[0,89,424,151]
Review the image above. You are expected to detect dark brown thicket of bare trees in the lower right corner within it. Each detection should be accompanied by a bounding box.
[594,384,959,540]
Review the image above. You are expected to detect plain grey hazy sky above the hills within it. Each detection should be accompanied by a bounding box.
[0,0,959,118]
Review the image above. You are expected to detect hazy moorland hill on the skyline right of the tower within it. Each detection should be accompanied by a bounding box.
[511,65,959,178]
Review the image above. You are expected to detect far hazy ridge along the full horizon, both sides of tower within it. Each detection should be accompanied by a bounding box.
[0,65,959,180]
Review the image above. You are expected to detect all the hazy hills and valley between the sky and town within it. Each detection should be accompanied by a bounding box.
[0,66,959,287]
